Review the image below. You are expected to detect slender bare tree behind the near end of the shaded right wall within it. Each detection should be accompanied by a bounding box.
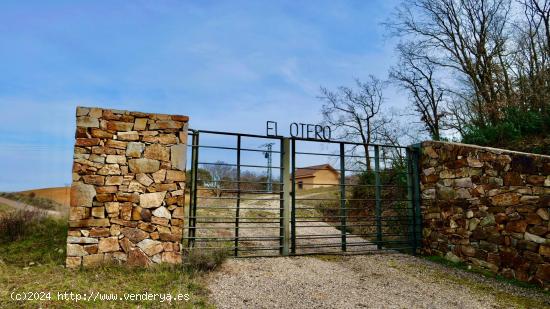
[390,43,447,140]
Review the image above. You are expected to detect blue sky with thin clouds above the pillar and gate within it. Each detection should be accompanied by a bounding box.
[0,0,406,191]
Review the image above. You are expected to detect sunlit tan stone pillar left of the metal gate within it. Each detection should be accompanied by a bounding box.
[66,107,189,268]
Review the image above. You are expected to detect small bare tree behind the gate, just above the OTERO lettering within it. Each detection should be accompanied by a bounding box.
[320,75,392,170]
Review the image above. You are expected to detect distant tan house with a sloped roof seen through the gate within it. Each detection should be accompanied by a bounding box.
[296,164,340,190]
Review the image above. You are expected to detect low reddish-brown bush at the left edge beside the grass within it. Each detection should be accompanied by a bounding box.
[0,210,44,241]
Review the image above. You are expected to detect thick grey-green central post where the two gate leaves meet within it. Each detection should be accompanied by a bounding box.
[281,138,293,256]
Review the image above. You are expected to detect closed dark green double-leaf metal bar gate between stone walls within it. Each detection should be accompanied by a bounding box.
[185,130,421,257]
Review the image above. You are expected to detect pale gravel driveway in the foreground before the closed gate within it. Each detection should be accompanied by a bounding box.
[209,254,550,308]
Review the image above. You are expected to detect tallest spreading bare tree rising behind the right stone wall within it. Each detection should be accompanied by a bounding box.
[389,0,512,127]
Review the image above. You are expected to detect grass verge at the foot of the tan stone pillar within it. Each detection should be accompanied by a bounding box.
[0,213,215,308]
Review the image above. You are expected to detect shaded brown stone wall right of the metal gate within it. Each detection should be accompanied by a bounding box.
[420,142,550,286]
